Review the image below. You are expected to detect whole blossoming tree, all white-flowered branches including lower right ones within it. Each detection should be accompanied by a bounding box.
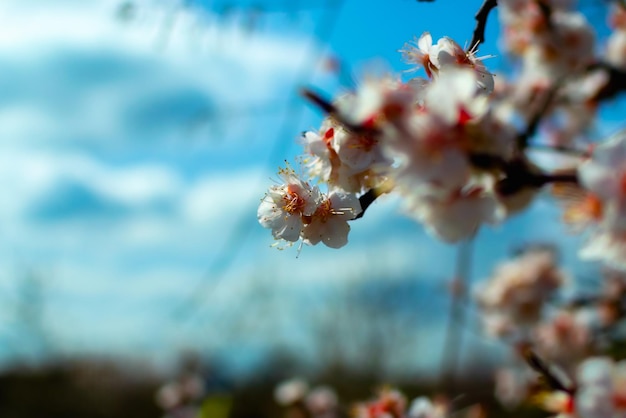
[258,0,626,418]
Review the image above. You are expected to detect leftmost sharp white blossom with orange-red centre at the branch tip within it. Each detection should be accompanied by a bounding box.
[257,168,321,242]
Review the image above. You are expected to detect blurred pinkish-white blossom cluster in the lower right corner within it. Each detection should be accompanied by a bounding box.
[476,247,626,418]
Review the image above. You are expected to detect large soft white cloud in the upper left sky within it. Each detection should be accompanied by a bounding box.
[0,1,316,148]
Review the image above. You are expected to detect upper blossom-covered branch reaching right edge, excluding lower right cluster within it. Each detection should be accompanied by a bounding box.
[258,0,626,269]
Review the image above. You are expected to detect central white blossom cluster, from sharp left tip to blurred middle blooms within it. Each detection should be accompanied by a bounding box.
[258,33,530,247]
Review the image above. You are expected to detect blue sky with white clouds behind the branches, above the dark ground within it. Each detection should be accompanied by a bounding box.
[0,0,608,378]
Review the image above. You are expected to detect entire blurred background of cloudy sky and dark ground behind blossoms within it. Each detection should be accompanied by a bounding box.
[0,0,619,418]
